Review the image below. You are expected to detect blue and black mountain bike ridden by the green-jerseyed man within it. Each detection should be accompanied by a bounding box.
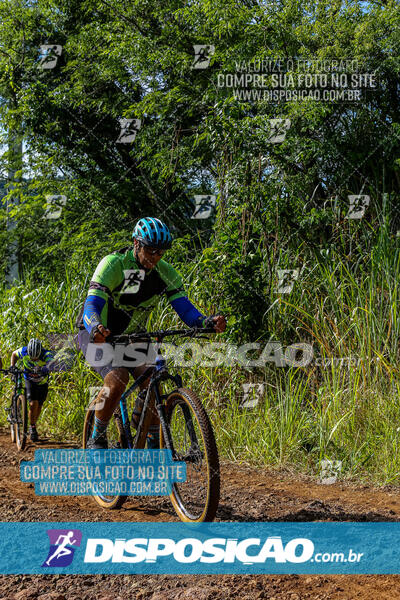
[83,328,220,522]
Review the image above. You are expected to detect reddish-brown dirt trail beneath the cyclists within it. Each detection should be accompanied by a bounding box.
[0,431,400,600]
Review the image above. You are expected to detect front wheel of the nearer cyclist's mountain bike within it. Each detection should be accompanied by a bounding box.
[160,388,220,523]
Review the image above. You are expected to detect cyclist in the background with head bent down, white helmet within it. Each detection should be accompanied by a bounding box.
[11,338,54,442]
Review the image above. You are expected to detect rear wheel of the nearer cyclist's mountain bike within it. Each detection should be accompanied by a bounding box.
[83,400,128,509]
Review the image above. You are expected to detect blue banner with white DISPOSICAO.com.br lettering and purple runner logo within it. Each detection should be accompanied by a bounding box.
[0,522,400,574]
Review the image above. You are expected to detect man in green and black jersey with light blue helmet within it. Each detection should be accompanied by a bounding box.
[78,217,226,449]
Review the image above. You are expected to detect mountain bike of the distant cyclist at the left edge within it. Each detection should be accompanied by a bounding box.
[0,367,28,450]
